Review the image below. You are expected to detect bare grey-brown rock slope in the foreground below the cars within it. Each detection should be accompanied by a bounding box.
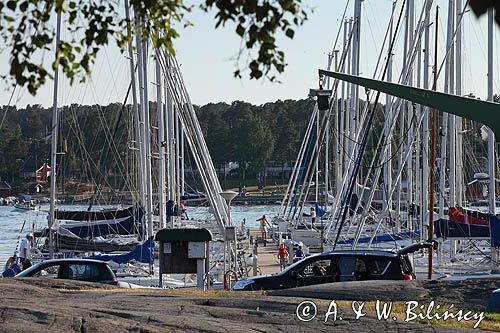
[0,279,500,333]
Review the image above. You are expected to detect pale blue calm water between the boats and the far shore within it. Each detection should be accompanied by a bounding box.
[0,205,279,271]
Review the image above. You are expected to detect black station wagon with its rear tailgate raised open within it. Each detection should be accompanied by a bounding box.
[233,241,437,290]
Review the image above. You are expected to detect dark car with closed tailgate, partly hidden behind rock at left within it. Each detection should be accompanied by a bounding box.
[15,259,117,284]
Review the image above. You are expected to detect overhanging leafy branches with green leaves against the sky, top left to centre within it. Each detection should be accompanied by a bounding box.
[0,0,308,95]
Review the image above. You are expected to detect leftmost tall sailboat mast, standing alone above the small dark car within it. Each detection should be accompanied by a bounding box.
[49,13,61,259]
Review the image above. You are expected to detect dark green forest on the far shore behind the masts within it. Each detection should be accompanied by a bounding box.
[0,94,492,194]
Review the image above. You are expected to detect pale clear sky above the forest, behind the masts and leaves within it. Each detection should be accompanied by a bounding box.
[0,0,500,107]
